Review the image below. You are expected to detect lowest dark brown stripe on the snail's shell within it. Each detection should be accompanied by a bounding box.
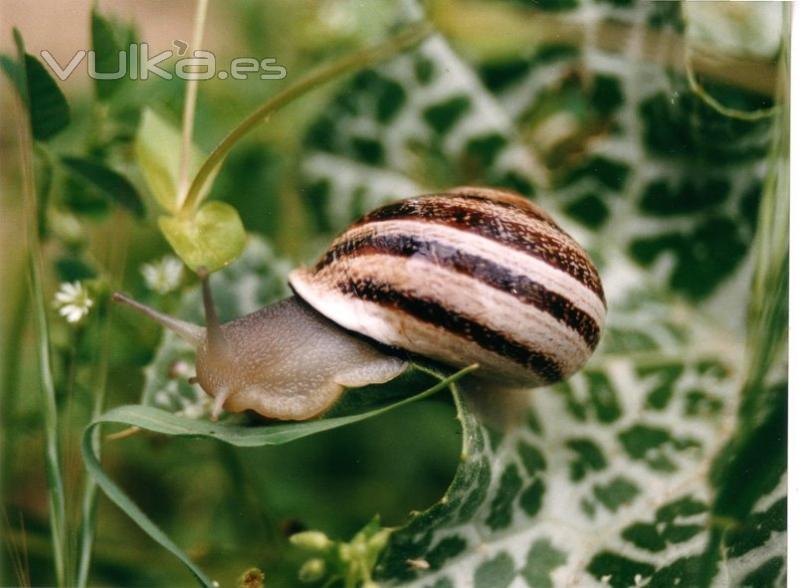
[336,278,562,382]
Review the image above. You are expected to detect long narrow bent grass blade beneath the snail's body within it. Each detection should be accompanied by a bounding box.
[81,368,473,588]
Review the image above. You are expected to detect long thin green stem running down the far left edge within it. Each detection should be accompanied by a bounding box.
[13,33,67,586]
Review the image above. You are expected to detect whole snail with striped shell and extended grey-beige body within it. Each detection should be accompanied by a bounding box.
[114,187,606,420]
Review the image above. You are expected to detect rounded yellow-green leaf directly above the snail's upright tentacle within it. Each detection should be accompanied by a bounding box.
[158,201,247,272]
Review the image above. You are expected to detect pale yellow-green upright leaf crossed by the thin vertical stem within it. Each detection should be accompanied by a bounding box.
[134,108,204,213]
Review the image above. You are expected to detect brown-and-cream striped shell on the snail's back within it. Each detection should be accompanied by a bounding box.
[289,187,606,386]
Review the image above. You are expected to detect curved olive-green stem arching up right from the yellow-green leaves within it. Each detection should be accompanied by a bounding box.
[180,24,432,212]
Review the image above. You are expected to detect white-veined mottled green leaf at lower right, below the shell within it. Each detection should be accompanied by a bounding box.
[382,284,785,586]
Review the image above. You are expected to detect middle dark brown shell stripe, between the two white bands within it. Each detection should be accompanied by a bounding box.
[315,234,600,350]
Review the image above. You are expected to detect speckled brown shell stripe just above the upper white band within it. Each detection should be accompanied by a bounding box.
[356,195,606,306]
